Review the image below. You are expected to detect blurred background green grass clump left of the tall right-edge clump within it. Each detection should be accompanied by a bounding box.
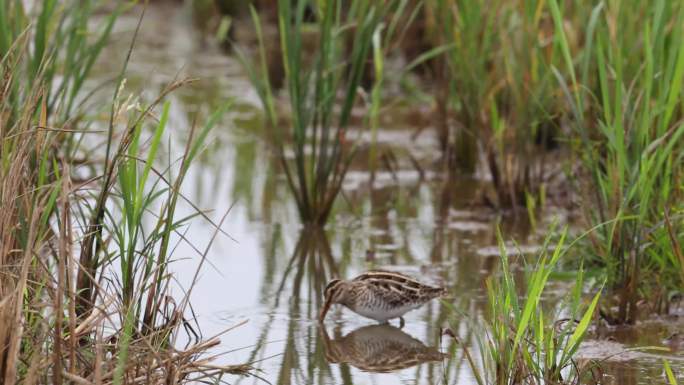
[425,0,562,209]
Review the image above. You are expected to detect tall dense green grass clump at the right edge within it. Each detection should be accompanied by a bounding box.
[549,0,684,323]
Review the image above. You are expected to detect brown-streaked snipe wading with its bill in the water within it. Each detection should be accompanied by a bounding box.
[319,271,446,326]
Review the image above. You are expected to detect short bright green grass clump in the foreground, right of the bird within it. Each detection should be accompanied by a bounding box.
[448,226,601,385]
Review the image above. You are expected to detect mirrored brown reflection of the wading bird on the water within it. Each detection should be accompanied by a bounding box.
[321,325,447,373]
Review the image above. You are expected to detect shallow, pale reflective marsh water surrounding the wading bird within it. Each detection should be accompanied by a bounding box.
[98,5,684,384]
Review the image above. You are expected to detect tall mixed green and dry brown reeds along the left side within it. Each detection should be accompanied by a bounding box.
[0,0,248,384]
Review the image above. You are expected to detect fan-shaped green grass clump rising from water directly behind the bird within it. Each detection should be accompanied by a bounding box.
[245,0,397,225]
